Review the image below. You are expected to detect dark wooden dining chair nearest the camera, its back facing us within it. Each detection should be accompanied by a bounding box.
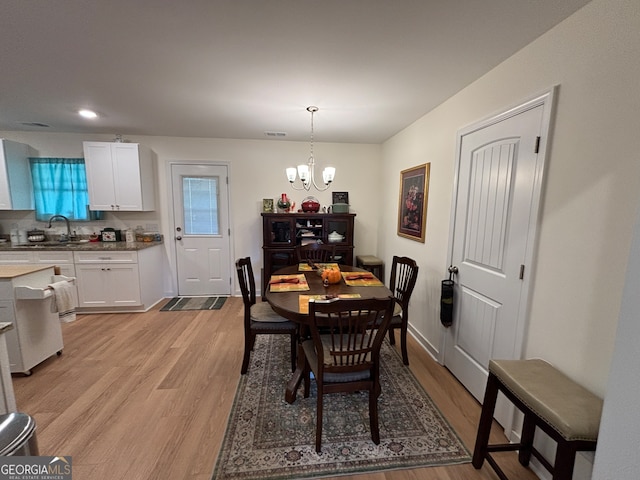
[302,297,394,452]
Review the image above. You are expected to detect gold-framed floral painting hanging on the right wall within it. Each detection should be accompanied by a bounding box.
[398,163,431,243]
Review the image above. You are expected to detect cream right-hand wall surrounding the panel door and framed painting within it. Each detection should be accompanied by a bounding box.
[379,0,640,395]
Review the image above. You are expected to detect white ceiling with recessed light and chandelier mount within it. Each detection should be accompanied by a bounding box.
[0,0,588,143]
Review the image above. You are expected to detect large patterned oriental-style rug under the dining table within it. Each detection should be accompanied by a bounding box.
[212,335,471,480]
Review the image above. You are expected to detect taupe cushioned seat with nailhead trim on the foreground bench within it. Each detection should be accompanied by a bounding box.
[489,359,602,441]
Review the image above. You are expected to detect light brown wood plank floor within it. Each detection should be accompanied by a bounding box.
[13,298,537,480]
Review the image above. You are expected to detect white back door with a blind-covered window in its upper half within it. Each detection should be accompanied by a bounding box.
[171,164,231,296]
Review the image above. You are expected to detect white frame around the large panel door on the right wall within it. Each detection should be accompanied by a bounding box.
[438,85,558,432]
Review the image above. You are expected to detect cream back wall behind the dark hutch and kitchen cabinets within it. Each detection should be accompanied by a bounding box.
[0,132,382,295]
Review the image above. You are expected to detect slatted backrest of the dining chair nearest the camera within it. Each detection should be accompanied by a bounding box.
[309,297,393,378]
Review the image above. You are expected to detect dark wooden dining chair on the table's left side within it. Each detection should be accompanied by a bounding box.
[236,257,298,375]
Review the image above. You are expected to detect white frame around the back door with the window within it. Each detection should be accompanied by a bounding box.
[165,160,236,296]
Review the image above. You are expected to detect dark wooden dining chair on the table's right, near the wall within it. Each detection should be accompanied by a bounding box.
[389,256,418,365]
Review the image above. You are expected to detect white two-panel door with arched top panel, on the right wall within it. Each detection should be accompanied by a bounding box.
[444,92,551,429]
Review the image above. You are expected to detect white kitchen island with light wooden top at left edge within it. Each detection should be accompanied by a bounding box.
[0,265,69,375]
